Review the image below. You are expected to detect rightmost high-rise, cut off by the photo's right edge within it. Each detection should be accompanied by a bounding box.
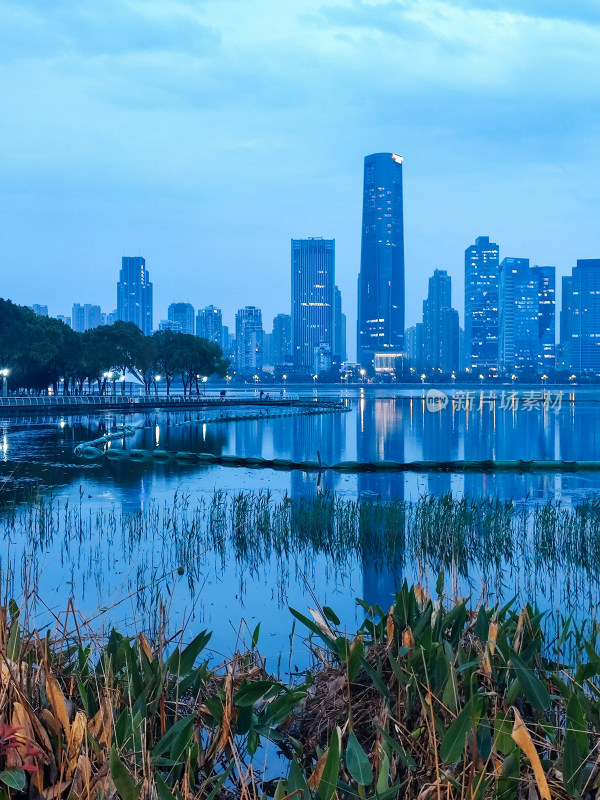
[560,258,600,374]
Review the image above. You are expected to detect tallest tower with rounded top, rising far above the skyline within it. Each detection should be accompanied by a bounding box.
[357,153,404,367]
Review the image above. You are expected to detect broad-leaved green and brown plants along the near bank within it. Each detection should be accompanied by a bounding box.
[0,577,600,800]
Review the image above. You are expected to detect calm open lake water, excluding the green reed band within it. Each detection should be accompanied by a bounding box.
[0,387,600,654]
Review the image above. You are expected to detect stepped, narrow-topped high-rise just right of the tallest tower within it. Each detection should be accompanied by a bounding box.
[423,269,460,373]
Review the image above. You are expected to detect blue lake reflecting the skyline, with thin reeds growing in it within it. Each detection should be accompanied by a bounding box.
[0,386,600,668]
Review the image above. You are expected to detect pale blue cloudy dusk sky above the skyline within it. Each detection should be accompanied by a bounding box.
[0,0,600,357]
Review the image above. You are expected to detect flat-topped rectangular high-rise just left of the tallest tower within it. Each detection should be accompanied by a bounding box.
[292,238,335,370]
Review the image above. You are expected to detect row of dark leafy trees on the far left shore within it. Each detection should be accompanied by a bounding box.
[0,298,229,393]
